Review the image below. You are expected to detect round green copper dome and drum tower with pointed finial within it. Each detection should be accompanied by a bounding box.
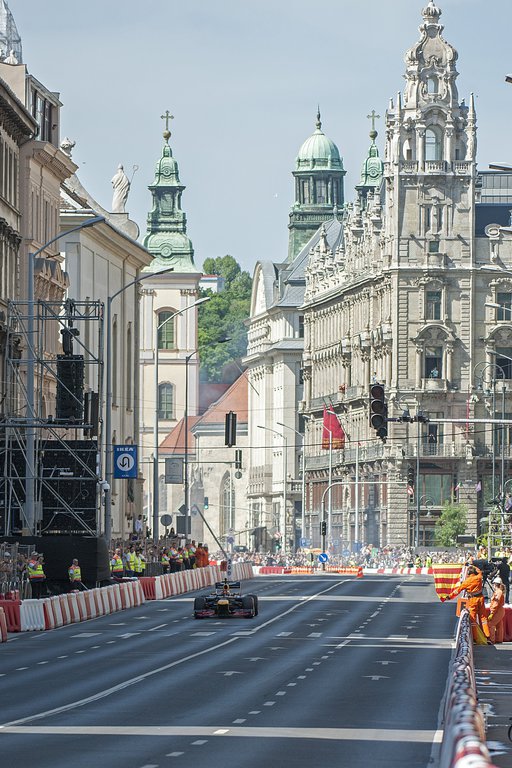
[288,110,345,261]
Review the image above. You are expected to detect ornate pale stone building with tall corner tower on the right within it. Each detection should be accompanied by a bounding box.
[302,0,512,550]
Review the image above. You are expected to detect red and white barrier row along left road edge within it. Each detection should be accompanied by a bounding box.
[0,563,253,642]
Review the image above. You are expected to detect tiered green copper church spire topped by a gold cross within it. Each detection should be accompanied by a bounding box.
[144,110,197,272]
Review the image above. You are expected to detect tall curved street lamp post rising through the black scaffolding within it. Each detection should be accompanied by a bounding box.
[25,216,105,534]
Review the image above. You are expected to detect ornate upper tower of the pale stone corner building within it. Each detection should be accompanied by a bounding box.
[385,0,476,267]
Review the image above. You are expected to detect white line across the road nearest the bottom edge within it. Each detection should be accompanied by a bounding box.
[0,725,443,744]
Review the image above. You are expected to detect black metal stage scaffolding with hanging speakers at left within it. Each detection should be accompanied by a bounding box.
[0,299,104,536]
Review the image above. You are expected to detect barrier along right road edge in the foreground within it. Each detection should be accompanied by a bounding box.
[439,609,494,768]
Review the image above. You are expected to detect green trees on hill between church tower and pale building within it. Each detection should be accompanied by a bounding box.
[198,256,252,382]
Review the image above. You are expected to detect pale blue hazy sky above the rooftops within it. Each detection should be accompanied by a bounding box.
[8,0,512,272]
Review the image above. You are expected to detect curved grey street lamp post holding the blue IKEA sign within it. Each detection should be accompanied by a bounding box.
[104,267,174,546]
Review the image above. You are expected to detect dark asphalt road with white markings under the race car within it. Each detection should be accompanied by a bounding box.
[0,575,455,768]
